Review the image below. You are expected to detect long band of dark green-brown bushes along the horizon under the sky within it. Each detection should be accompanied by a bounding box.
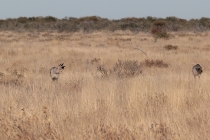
[0,16,210,32]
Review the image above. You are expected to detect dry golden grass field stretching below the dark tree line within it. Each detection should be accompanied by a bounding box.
[0,31,210,140]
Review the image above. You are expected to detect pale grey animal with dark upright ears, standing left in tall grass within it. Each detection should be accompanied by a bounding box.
[50,63,65,81]
